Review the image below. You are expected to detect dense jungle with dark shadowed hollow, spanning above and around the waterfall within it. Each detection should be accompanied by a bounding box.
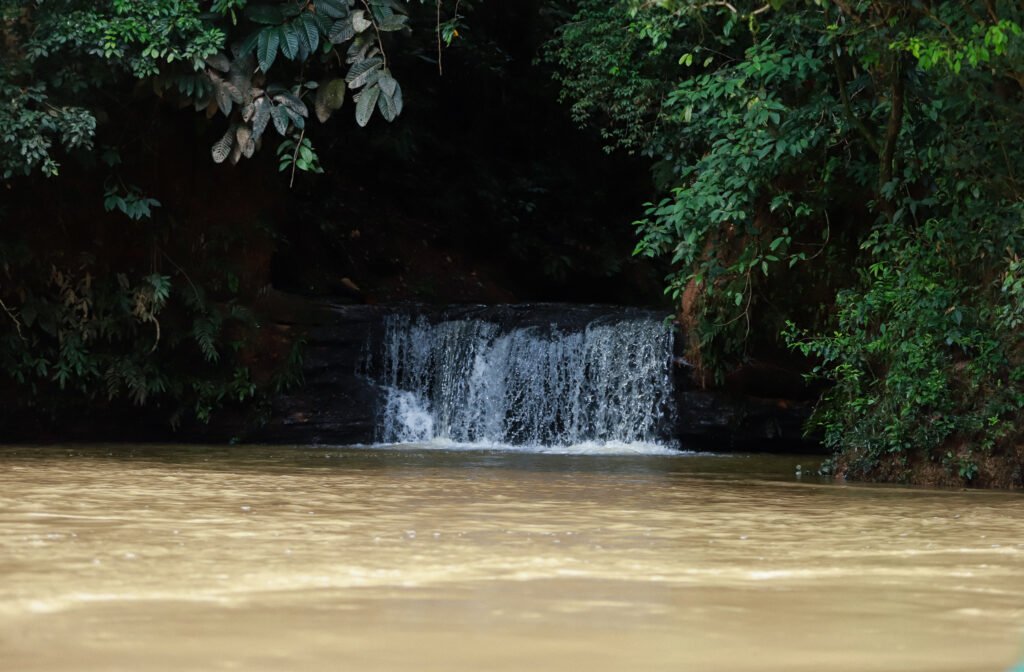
[0,0,1024,487]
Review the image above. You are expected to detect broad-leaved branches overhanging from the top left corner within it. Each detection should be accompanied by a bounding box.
[0,0,408,179]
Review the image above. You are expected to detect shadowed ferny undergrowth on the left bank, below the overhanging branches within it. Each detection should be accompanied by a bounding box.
[0,220,272,424]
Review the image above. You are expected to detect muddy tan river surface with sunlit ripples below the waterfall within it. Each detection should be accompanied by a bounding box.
[0,446,1024,672]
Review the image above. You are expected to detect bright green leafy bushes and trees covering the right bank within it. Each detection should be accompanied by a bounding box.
[553,0,1024,481]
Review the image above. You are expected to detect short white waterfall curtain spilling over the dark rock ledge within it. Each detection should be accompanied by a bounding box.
[370,313,674,447]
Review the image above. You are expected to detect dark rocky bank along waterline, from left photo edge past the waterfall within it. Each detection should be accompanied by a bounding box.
[0,293,820,452]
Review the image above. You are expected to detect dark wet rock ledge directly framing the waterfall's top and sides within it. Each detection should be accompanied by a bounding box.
[243,300,819,452]
